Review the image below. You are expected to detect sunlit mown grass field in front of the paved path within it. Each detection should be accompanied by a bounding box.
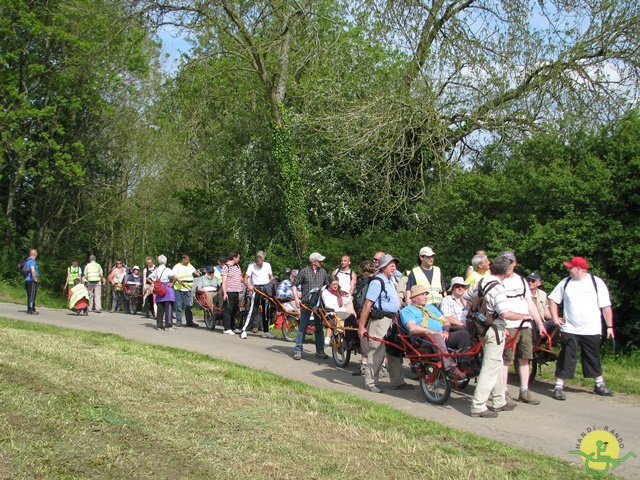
[0,319,586,479]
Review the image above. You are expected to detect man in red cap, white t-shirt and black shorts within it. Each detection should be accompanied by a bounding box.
[549,257,614,400]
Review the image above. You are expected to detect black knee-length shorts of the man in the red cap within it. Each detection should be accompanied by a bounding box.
[556,332,602,378]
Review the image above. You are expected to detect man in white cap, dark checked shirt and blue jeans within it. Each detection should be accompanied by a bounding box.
[291,252,329,360]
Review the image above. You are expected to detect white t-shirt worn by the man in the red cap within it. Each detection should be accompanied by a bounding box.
[549,275,611,335]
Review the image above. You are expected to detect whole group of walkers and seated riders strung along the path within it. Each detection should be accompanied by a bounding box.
[25,247,614,418]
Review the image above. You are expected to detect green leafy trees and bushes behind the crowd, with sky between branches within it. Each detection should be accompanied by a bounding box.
[0,0,640,343]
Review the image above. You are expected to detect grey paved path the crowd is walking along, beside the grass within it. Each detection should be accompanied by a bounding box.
[0,303,640,479]
